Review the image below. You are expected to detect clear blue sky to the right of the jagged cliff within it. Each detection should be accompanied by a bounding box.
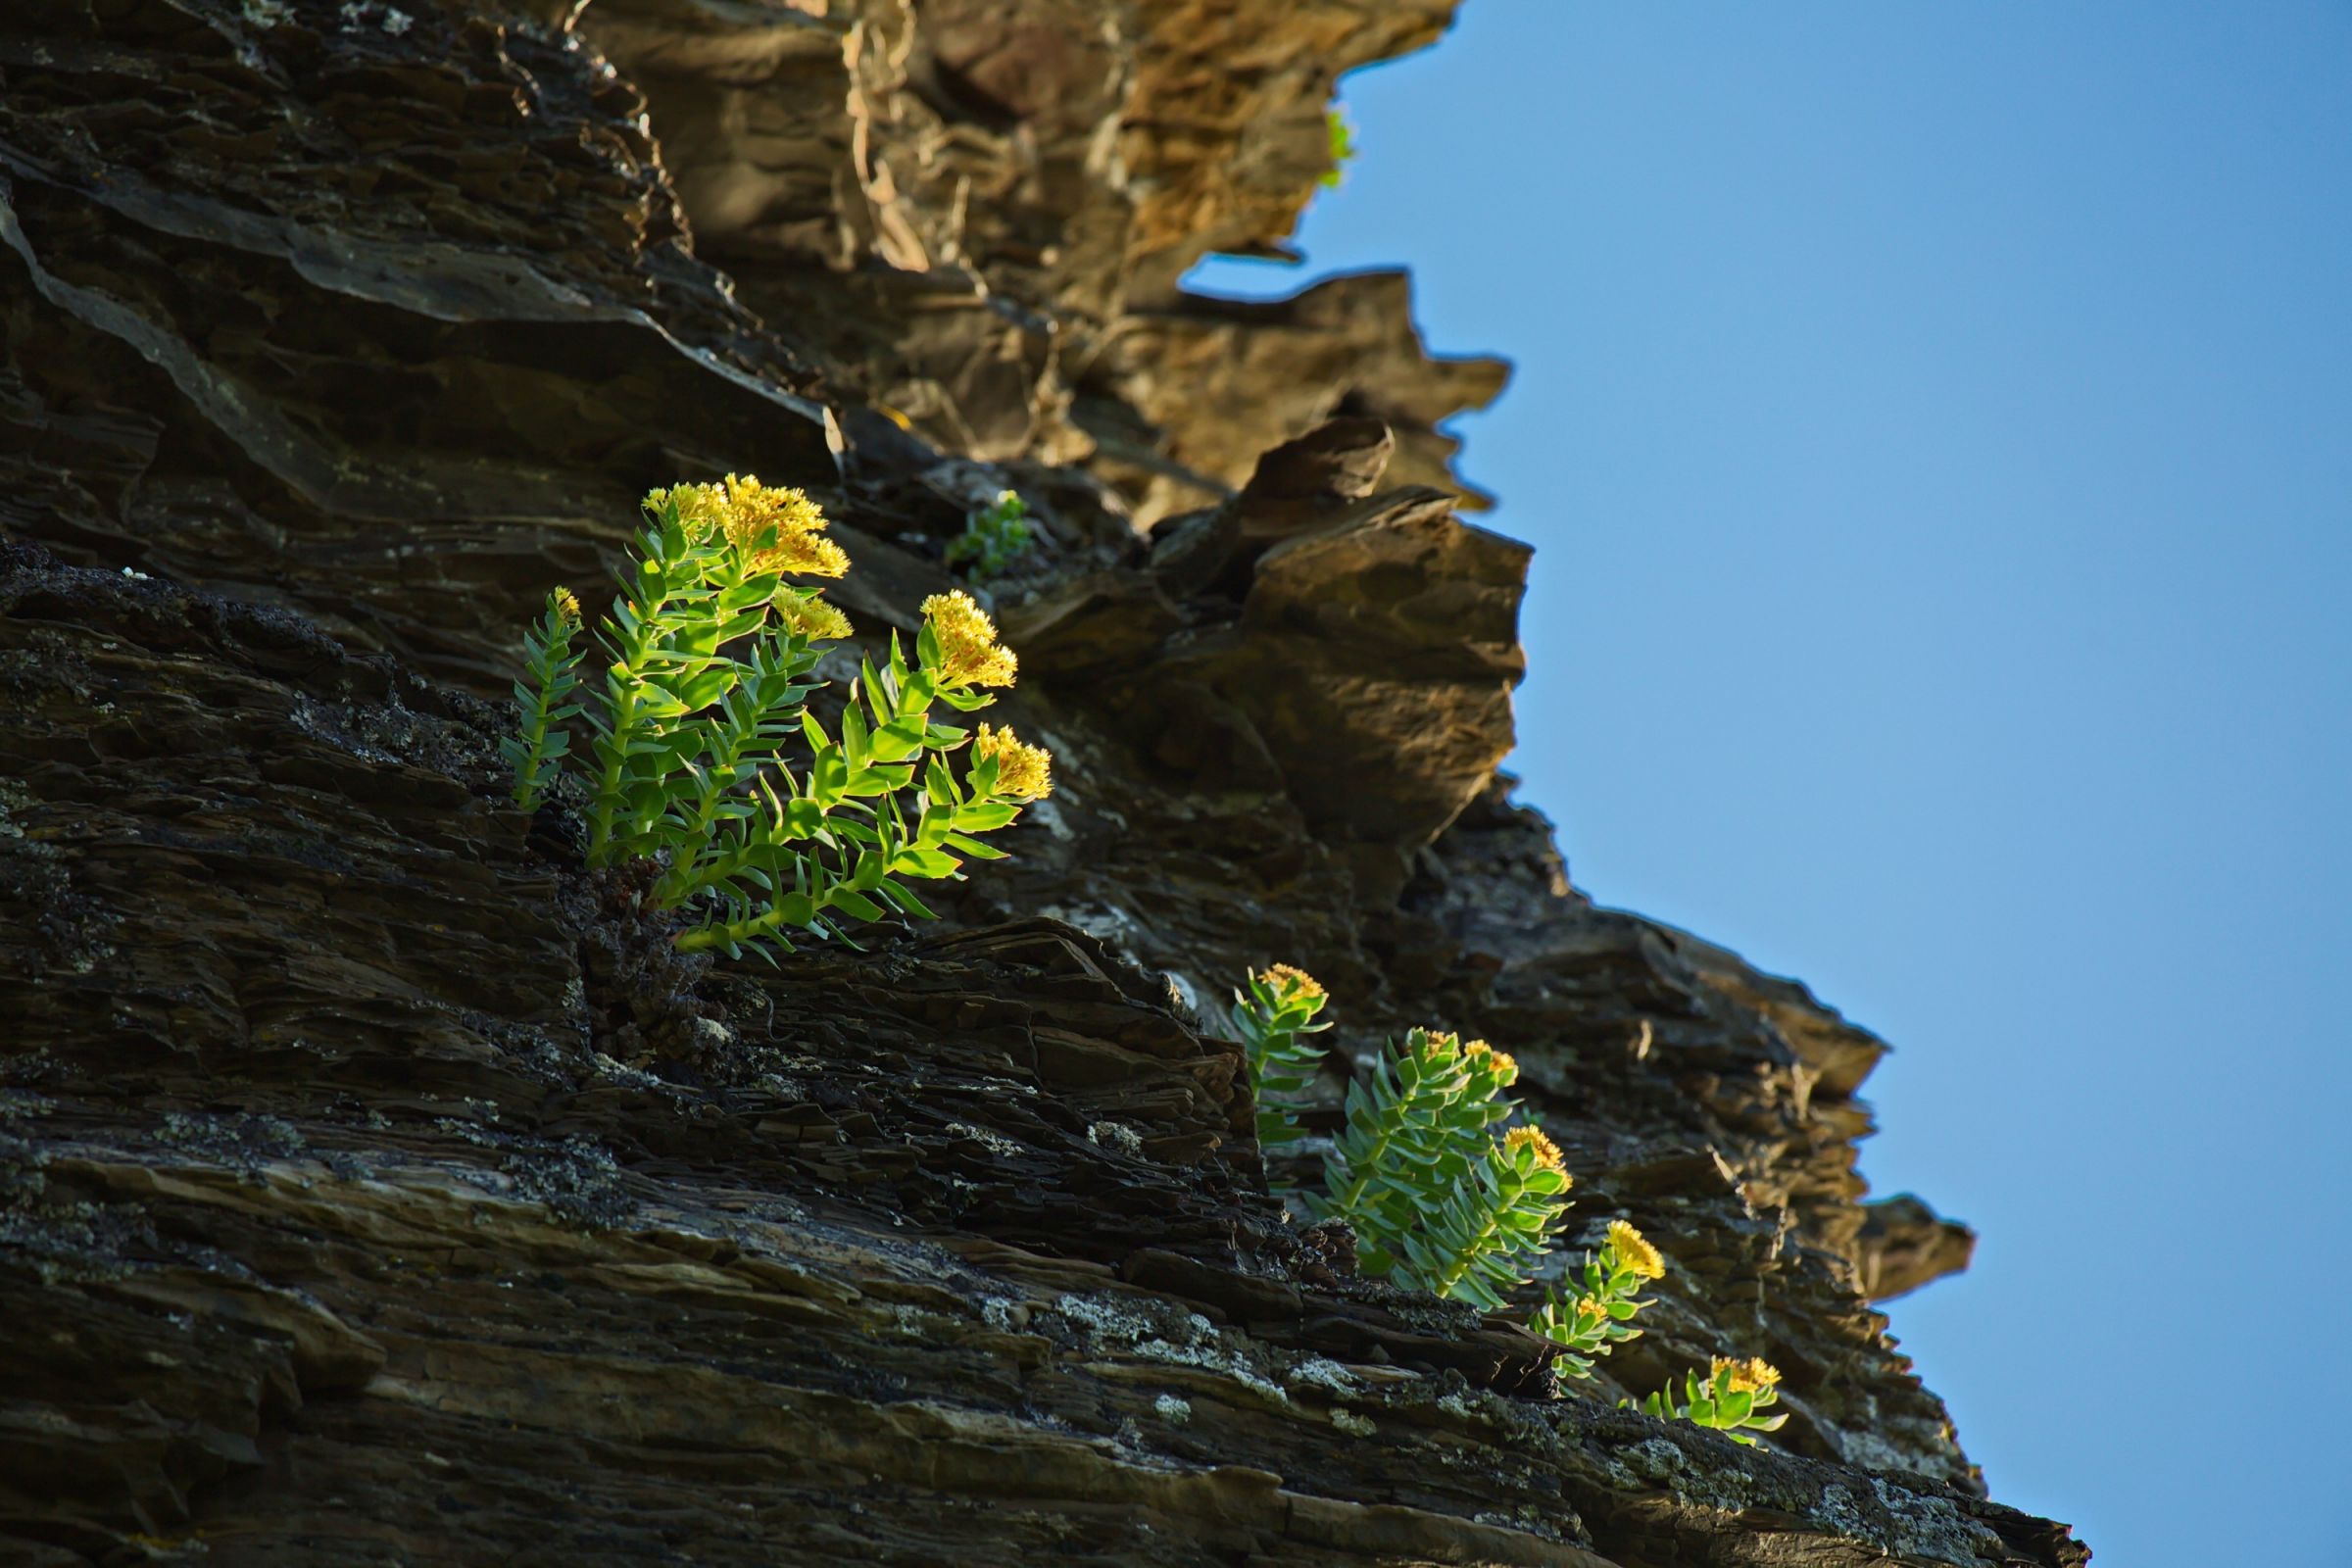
[1198,0,2352,1568]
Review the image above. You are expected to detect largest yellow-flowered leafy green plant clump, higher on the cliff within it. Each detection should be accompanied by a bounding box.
[504,475,1052,961]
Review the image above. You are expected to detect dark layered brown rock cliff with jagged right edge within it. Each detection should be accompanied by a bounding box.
[0,0,2086,1568]
